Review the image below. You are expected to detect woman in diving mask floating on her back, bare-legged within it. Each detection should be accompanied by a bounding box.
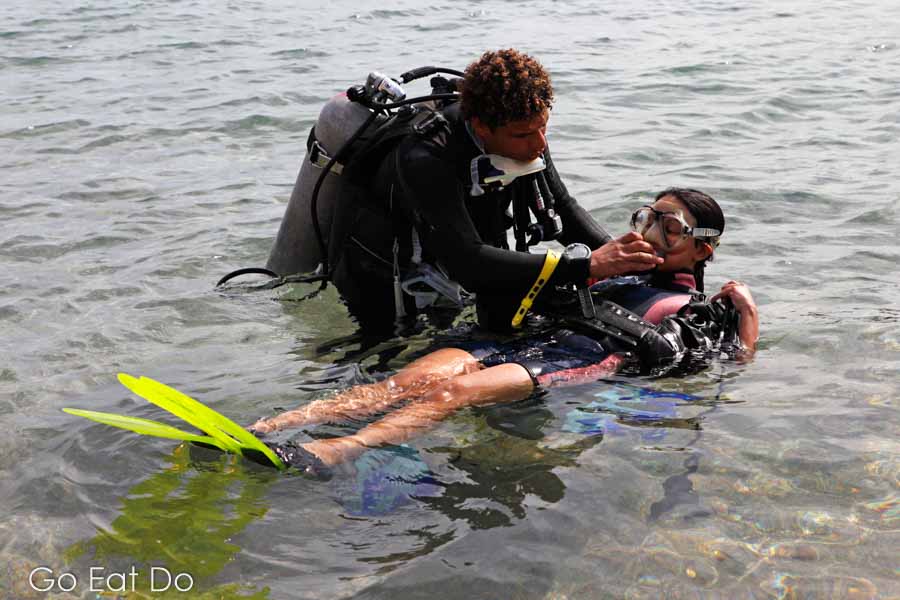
[250,188,759,475]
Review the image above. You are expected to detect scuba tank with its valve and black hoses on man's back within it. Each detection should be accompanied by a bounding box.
[216,66,464,300]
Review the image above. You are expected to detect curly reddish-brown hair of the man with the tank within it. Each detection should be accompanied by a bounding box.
[460,48,553,130]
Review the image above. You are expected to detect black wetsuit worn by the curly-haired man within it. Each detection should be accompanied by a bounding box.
[334,104,610,330]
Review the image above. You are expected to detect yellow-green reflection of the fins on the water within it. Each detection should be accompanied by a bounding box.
[64,444,277,599]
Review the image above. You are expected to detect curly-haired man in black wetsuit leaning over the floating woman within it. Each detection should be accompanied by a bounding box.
[334,49,662,330]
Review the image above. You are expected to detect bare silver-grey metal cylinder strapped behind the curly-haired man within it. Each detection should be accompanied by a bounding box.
[266,93,385,275]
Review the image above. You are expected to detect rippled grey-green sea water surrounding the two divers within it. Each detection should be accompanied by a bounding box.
[0,0,900,599]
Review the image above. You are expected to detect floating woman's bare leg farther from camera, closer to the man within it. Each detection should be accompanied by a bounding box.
[250,348,481,433]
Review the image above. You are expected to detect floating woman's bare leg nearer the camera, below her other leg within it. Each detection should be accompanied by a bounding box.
[303,364,534,465]
